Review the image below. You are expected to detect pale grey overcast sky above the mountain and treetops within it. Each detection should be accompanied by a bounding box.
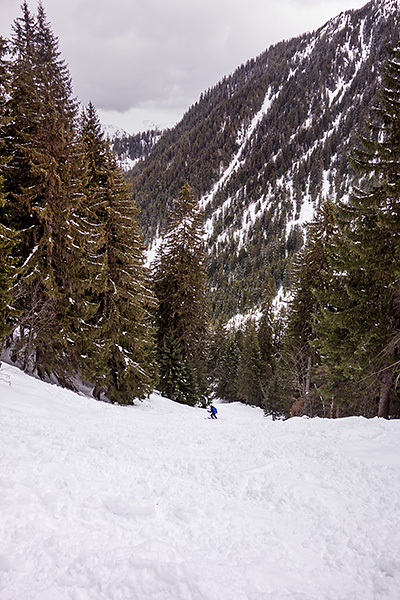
[0,0,367,133]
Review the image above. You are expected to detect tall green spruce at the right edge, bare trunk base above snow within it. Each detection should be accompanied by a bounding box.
[318,46,400,417]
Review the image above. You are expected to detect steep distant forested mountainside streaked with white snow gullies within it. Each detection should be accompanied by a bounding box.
[125,0,399,317]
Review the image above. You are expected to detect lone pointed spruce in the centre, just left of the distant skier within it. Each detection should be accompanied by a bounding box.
[154,184,208,404]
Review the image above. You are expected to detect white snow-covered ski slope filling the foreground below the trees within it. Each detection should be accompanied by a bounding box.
[0,364,400,600]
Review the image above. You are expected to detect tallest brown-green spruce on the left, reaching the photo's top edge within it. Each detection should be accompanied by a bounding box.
[5,2,77,382]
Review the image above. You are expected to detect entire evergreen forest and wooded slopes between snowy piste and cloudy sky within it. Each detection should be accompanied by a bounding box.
[0,0,400,418]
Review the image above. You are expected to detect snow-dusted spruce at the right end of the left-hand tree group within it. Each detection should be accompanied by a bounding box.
[76,103,154,404]
